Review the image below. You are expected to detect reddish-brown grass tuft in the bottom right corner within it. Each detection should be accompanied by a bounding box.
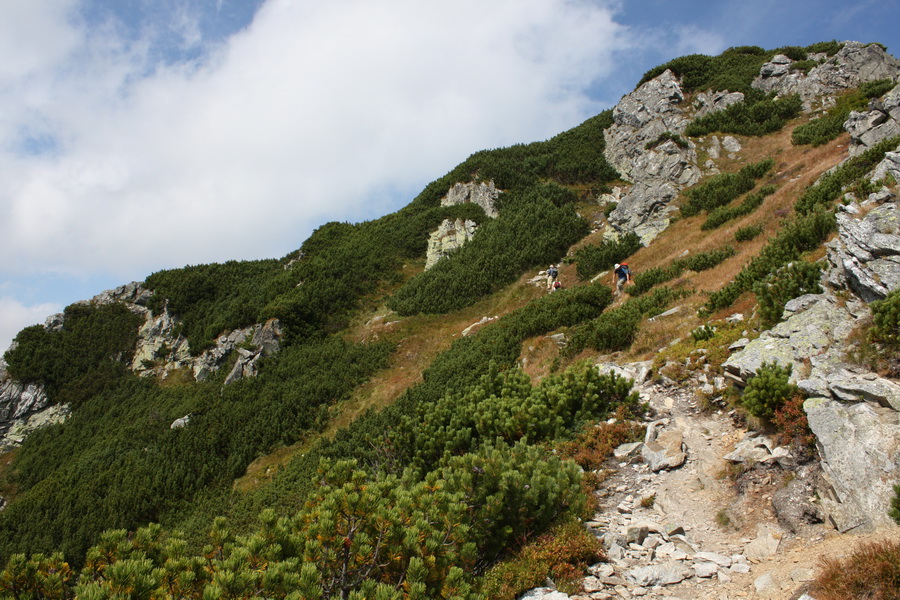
[810,540,900,600]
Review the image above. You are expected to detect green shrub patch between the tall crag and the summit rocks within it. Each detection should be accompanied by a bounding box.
[684,90,803,137]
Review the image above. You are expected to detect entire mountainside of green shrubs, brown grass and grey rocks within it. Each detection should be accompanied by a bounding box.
[0,43,900,598]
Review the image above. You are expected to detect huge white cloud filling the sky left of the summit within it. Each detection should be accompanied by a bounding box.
[0,0,631,280]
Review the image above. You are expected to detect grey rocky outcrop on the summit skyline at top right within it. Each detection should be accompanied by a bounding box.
[752,42,900,109]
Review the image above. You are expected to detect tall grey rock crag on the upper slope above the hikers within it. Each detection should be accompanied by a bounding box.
[604,71,704,244]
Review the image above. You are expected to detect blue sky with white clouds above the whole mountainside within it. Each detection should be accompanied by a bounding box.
[0,0,900,350]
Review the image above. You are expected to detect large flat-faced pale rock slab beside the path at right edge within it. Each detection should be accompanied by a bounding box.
[803,398,900,531]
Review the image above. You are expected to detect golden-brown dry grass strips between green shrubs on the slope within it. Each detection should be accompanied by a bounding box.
[235,113,848,491]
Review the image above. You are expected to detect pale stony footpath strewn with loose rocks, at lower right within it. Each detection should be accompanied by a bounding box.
[524,370,876,600]
